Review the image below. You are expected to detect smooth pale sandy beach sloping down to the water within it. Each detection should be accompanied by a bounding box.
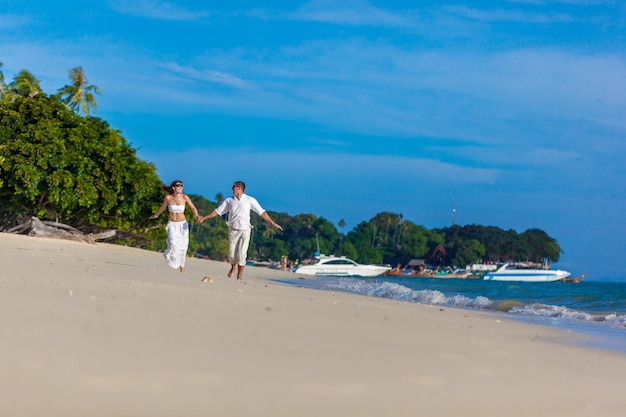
[0,233,626,417]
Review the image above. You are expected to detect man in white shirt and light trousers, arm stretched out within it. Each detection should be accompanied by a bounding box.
[197,181,283,279]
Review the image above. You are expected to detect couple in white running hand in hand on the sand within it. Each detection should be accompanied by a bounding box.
[150,180,283,279]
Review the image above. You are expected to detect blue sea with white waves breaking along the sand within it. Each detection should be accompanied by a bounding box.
[280,276,626,353]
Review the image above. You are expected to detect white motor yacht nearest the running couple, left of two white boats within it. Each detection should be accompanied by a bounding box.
[295,255,391,277]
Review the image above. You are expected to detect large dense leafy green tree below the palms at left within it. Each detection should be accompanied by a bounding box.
[0,94,163,237]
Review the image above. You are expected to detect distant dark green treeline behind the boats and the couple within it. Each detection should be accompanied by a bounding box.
[189,195,561,267]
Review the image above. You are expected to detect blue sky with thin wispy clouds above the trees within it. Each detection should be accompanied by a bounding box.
[0,0,626,280]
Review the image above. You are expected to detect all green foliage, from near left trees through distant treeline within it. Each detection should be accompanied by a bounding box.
[0,63,561,266]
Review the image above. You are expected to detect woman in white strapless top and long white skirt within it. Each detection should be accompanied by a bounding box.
[150,180,198,272]
